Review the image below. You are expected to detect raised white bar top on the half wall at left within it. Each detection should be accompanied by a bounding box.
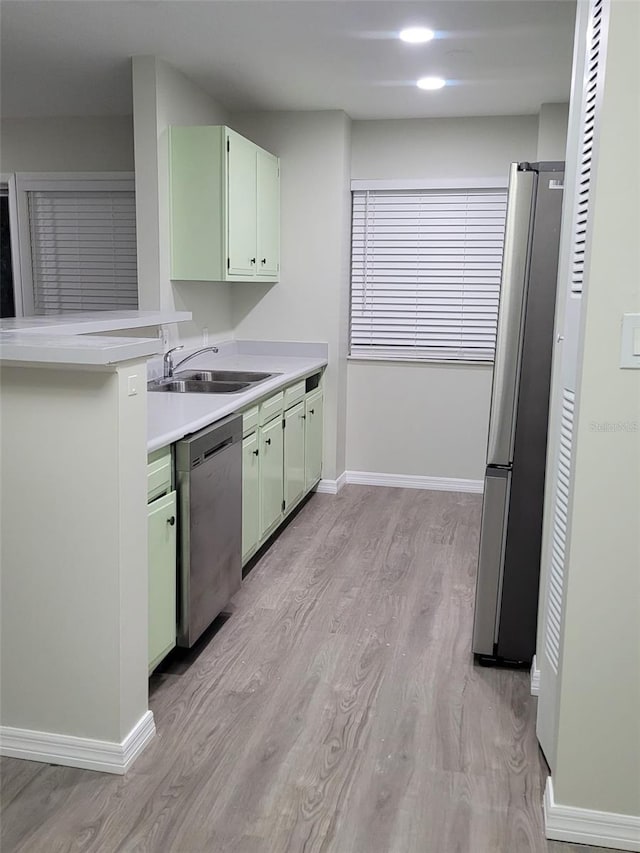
[0,311,191,368]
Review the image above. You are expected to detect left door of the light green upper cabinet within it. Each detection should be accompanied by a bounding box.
[227,130,259,278]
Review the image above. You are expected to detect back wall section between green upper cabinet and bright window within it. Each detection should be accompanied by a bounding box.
[231,111,351,479]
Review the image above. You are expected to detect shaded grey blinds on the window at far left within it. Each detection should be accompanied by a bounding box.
[27,182,138,314]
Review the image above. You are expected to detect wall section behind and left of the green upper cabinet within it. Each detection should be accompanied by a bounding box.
[133,56,234,346]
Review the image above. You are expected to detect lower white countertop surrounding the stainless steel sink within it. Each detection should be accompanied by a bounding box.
[147,353,327,453]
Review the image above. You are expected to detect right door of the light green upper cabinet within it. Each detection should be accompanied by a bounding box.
[256,148,280,278]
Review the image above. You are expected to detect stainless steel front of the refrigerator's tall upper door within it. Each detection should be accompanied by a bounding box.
[487,163,537,465]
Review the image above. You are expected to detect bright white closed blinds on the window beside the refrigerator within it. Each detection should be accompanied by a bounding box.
[351,189,507,361]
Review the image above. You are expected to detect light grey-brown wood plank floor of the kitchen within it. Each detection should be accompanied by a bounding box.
[1,486,620,853]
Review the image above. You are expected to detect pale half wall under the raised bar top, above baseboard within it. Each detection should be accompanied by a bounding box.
[0,362,148,744]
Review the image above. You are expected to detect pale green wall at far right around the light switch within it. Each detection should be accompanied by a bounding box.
[553,2,640,816]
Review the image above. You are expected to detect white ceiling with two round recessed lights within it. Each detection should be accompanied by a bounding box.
[0,0,575,119]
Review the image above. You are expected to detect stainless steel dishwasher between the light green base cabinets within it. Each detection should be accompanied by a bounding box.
[176,415,242,648]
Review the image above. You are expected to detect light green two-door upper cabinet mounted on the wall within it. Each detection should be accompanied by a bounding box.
[169,126,280,281]
